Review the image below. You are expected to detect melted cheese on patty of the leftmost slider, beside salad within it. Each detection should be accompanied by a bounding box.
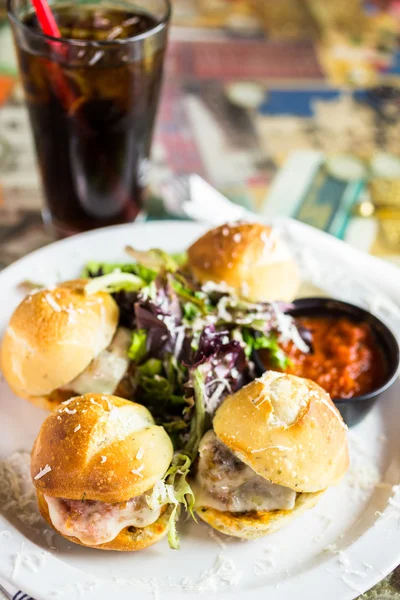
[65,327,131,394]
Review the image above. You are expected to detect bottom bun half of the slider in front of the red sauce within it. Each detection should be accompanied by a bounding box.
[196,490,325,540]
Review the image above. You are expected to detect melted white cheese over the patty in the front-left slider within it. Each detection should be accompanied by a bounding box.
[45,494,160,546]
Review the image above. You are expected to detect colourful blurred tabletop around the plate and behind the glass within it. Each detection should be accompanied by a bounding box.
[0,0,400,600]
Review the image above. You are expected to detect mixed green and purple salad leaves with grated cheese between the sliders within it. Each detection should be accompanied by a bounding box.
[82,248,308,548]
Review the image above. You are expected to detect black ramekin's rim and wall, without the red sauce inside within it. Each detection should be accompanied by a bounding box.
[253,298,400,426]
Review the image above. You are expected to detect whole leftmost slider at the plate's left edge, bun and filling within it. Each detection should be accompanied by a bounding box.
[1,280,131,409]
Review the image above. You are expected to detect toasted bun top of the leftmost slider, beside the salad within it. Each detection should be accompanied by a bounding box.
[1,280,119,397]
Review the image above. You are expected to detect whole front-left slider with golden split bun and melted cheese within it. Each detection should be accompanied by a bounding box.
[31,394,176,551]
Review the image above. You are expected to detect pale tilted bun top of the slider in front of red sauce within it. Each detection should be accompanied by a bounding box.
[213,371,349,492]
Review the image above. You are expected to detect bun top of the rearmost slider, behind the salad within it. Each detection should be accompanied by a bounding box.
[188,223,300,302]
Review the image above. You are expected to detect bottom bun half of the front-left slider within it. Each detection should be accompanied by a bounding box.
[36,490,173,552]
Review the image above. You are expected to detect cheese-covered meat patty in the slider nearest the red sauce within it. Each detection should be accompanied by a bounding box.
[194,431,296,512]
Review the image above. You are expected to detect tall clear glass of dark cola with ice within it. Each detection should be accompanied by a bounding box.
[12,4,167,235]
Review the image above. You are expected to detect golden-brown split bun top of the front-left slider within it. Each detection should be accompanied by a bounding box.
[31,394,173,503]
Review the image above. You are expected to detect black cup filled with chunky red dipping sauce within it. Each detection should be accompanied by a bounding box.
[254,298,400,426]
